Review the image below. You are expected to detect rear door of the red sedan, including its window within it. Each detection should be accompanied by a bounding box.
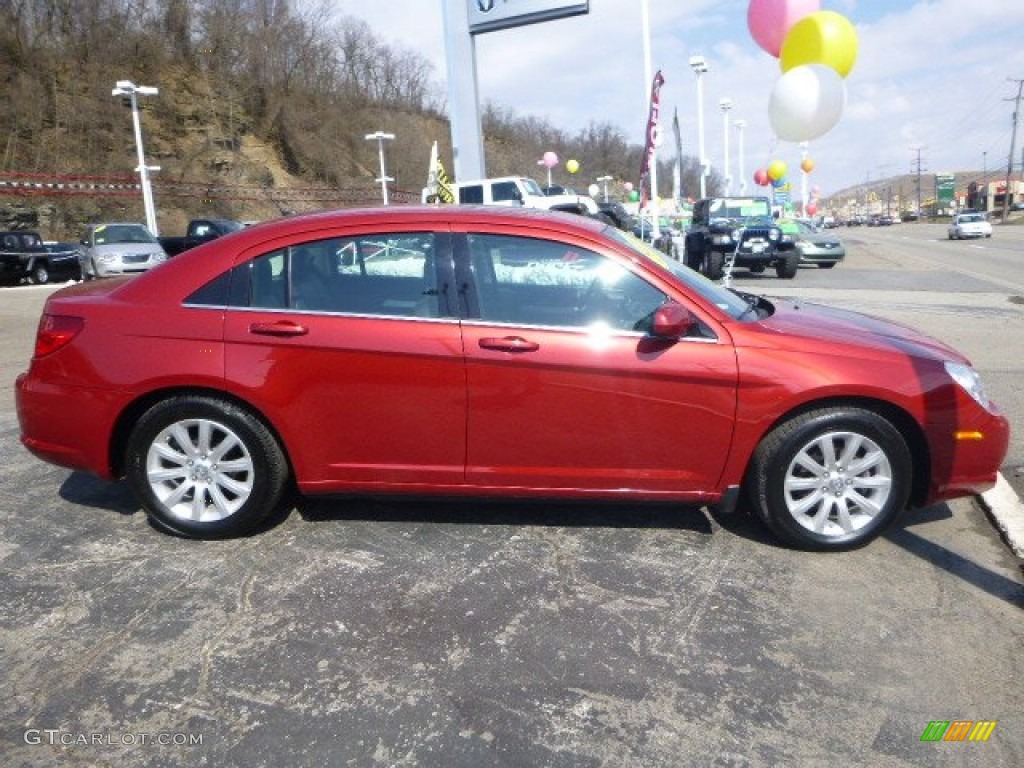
[225,231,466,492]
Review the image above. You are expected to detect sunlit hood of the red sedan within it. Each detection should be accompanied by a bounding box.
[756,299,968,362]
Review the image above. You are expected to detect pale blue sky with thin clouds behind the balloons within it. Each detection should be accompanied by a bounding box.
[332,0,1024,197]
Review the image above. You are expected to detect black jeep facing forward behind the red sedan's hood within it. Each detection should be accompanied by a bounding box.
[684,198,800,280]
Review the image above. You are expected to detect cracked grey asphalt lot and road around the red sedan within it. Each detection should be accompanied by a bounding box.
[0,225,1024,768]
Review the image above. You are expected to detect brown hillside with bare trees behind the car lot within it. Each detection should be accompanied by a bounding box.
[0,0,717,239]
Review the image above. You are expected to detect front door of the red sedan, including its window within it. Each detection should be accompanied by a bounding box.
[456,232,737,497]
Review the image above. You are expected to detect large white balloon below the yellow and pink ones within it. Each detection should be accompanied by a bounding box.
[768,63,846,141]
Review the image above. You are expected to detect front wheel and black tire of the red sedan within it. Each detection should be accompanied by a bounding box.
[748,407,912,551]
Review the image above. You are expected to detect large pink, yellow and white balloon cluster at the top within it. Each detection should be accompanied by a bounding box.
[746,0,857,141]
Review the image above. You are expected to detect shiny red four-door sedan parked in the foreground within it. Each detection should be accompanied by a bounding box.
[16,206,1009,549]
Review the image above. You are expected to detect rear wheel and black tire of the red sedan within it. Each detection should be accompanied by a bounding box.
[125,395,288,539]
